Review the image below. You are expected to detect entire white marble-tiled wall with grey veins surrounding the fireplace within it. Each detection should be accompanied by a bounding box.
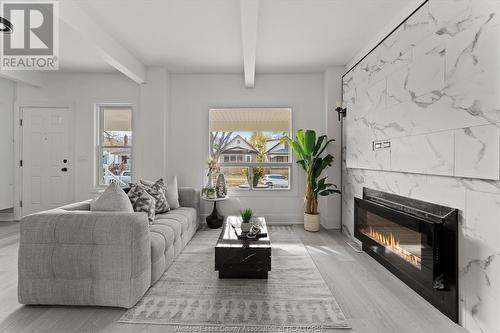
[342,0,500,333]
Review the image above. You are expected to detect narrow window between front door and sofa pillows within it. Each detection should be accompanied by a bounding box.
[96,105,133,186]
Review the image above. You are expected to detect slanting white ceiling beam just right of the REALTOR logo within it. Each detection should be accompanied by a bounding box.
[59,0,146,84]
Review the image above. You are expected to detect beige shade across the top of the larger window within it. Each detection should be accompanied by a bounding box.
[209,108,291,132]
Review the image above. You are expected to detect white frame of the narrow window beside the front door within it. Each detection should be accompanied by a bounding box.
[94,103,134,189]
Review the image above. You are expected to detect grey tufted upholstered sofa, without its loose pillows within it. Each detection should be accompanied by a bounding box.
[18,188,200,308]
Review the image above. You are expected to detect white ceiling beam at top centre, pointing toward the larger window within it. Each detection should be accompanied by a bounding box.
[240,0,259,88]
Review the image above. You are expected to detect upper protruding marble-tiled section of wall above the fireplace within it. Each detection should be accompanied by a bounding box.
[343,0,500,180]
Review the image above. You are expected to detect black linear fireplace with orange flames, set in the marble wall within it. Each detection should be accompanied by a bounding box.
[354,188,458,322]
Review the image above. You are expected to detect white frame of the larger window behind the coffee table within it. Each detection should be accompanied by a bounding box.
[208,107,295,192]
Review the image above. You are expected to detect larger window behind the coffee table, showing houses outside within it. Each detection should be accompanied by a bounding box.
[209,108,292,190]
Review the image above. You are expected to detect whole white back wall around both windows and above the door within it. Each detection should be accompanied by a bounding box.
[10,68,341,228]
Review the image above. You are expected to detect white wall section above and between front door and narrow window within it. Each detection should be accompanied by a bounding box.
[17,73,140,200]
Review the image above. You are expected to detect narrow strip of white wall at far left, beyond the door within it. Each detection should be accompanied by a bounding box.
[0,78,15,209]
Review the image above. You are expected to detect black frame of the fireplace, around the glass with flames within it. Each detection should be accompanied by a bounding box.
[354,188,458,322]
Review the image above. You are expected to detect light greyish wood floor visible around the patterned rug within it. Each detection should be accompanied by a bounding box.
[0,222,465,333]
